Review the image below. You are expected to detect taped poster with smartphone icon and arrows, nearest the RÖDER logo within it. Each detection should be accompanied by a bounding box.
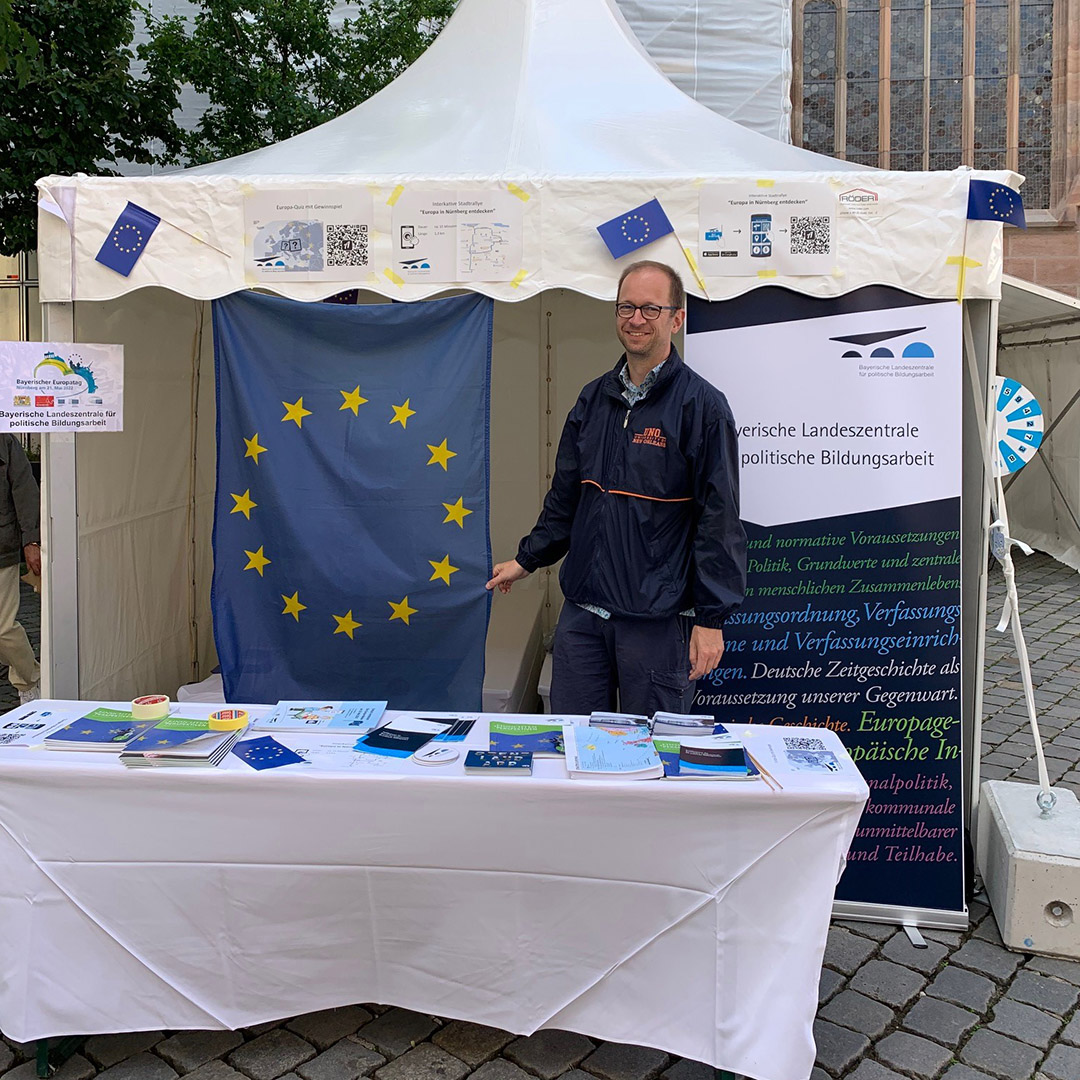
[698,180,836,278]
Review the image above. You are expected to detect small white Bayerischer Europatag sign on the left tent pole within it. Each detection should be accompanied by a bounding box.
[0,341,124,431]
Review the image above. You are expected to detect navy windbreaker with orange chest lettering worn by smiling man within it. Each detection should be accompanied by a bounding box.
[517,346,746,626]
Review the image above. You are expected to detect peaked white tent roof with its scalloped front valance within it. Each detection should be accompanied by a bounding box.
[39,0,1018,301]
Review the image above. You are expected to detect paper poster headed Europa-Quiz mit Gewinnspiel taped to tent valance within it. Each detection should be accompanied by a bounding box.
[244,190,374,281]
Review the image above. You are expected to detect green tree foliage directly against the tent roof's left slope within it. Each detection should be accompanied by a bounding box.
[139,0,455,164]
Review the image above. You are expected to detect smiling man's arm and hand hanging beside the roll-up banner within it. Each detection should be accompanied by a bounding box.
[690,414,746,681]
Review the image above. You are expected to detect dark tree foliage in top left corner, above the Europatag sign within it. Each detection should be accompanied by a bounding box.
[0,0,178,255]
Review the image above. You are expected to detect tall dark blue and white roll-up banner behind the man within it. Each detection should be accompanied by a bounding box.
[686,289,964,912]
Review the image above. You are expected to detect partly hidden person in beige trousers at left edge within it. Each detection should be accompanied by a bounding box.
[0,434,41,704]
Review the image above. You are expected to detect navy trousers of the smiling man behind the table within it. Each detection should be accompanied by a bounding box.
[551,600,694,716]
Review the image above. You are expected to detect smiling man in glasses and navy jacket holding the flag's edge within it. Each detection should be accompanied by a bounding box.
[487,261,746,715]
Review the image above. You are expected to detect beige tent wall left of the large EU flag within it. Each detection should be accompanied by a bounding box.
[60,289,214,700]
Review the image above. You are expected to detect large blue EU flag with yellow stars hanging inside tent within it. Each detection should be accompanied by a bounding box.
[212,294,492,710]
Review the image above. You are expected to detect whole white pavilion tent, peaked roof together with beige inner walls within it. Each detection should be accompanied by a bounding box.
[39,0,1006,743]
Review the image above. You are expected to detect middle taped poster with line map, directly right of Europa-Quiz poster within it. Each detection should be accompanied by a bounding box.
[393,188,523,282]
